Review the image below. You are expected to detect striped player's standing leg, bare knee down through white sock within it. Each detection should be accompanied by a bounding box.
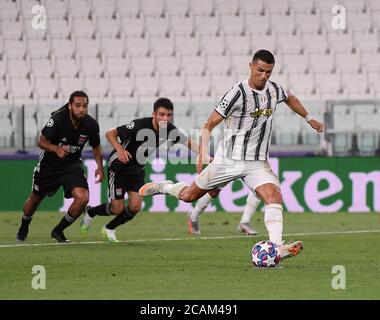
[255,183,283,245]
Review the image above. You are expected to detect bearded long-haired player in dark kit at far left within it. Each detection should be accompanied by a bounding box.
[16,91,103,242]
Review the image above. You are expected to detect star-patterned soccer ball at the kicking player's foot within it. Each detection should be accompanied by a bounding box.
[251,241,281,268]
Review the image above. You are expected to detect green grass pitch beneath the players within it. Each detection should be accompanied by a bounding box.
[0,212,380,300]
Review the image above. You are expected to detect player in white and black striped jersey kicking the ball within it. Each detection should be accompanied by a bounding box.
[139,50,323,259]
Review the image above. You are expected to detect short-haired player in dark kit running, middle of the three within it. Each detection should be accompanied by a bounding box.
[80,98,198,242]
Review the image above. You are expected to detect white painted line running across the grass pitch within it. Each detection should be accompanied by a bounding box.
[0,229,380,248]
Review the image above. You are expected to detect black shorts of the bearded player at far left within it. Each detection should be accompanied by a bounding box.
[32,166,88,199]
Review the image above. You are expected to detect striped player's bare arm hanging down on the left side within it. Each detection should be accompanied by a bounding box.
[197,111,224,173]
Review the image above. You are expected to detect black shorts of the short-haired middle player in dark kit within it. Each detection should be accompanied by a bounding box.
[108,168,145,200]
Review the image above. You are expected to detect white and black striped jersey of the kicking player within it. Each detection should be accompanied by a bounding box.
[215,80,288,160]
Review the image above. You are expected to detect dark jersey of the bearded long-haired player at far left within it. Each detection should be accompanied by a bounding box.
[38,109,100,170]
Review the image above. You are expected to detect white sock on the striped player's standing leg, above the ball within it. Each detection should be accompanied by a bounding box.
[264,203,283,245]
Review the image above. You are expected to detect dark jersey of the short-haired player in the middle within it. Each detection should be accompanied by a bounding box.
[108,117,188,173]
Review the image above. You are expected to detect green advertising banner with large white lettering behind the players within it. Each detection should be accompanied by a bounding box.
[0,157,380,213]
